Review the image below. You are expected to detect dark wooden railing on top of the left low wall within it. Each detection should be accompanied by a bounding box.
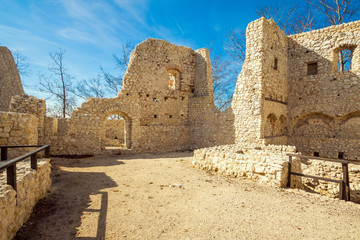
[0,145,50,191]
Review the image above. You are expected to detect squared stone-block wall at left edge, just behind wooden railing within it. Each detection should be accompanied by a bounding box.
[0,112,38,159]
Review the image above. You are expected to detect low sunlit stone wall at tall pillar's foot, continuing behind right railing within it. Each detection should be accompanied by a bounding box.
[193,145,360,202]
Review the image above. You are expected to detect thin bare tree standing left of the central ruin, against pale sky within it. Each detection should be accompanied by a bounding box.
[39,49,75,118]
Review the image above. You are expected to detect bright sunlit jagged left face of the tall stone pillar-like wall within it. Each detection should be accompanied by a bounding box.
[231,19,264,144]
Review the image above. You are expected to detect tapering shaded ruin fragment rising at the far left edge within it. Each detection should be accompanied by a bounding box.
[0,46,24,111]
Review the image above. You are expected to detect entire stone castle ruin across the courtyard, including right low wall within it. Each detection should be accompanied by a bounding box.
[0,18,360,201]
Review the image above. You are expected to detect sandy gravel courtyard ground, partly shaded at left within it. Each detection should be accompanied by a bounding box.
[15,152,360,240]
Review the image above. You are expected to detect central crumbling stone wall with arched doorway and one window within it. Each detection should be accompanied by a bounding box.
[33,39,235,155]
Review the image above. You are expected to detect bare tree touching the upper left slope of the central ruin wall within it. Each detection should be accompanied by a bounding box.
[100,43,133,95]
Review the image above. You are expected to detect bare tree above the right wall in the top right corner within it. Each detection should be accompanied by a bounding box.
[306,0,360,26]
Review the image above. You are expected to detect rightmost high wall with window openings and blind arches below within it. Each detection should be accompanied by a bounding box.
[288,21,360,159]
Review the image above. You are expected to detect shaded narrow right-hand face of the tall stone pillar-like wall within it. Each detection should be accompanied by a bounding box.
[259,20,288,145]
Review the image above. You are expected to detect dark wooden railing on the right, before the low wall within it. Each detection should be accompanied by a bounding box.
[287,154,360,201]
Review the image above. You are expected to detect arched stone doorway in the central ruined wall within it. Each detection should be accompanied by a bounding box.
[101,111,131,148]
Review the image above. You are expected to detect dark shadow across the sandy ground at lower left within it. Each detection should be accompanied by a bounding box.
[14,157,124,240]
